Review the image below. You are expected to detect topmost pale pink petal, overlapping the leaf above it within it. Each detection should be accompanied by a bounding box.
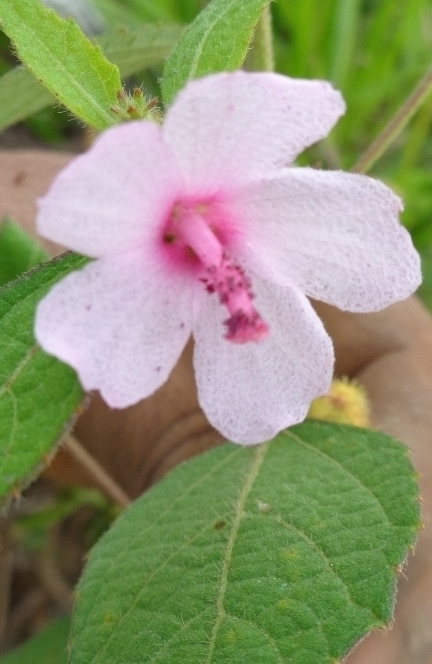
[163,72,345,191]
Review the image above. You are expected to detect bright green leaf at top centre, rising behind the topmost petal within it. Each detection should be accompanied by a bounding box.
[161,0,269,104]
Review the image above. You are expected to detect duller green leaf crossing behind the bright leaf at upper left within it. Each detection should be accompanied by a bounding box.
[0,25,183,131]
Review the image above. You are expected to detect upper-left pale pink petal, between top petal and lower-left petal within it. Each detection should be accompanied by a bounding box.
[37,121,184,257]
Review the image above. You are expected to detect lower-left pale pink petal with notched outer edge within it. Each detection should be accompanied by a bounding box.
[35,252,192,408]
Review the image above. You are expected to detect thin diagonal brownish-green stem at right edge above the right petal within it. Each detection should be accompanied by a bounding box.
[351,67,432,173]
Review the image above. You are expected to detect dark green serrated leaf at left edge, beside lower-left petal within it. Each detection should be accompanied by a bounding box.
[0,254,88,497]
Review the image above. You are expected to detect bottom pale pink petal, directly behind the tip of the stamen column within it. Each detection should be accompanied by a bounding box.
[193,279,333,445]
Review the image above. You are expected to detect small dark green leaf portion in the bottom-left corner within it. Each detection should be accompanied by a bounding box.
[0,617,70,664]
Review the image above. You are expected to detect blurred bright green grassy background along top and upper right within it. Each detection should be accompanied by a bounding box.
[4,0,432,308]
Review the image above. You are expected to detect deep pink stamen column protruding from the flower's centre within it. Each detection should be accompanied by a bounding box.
[163,203,269,343]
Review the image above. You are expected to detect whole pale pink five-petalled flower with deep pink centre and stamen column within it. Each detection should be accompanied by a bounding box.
[36,72,420,444]
